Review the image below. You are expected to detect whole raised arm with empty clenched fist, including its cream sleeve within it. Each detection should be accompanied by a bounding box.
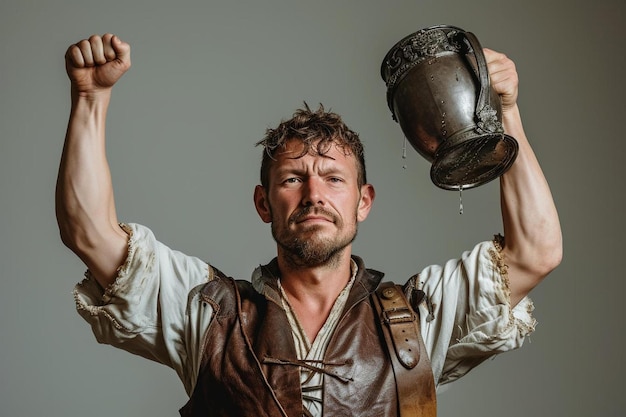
[56,34,213,394]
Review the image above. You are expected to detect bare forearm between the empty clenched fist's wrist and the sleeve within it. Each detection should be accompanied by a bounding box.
[56,91,127,286]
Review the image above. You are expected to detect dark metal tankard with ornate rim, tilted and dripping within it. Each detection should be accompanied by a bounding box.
[381,26,518,190]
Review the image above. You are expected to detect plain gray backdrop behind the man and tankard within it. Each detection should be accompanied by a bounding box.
[0,0,626,417]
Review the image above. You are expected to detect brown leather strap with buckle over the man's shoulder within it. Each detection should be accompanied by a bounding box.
[374,282,437,417]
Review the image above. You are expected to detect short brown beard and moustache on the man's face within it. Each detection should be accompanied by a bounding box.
[272,207,357,268]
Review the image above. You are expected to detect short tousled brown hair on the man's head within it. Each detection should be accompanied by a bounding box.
[257,102,367,188]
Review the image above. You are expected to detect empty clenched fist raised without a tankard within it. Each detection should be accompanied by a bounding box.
[65,33,130,95]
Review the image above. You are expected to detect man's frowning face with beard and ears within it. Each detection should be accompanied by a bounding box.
[255,140,373,266]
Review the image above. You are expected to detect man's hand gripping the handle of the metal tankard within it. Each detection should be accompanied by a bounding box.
[483,48,519,113]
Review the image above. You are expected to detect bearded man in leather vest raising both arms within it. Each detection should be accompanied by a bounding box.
[56,34,561,416]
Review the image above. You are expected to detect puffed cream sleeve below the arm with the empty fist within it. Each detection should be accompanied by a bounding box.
[74,224,211,390]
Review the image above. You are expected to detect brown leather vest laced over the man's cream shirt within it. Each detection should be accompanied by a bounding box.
[180,257,435,417]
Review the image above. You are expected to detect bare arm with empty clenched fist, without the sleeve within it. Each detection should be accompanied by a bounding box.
[56,34,130,288]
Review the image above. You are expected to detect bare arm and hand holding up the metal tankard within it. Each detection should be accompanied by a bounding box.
[485,49,562,306]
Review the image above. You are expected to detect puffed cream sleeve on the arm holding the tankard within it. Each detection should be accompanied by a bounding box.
[408,237,536,386]
